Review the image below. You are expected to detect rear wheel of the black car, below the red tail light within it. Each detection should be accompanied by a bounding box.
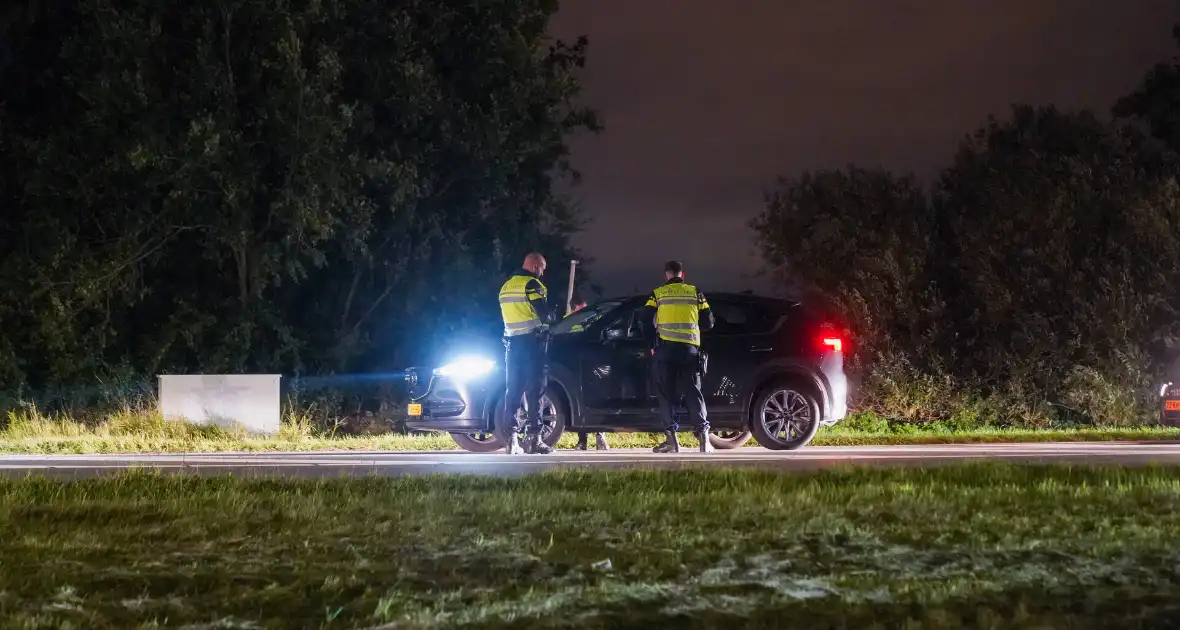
[749,380,820,451]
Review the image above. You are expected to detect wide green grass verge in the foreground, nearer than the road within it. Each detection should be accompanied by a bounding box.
[0,465,1180,630]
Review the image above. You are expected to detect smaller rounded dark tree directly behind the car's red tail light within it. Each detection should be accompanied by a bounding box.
[750,166,937,375]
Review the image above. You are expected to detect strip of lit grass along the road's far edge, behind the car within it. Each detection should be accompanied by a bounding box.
[0,411,1180,453]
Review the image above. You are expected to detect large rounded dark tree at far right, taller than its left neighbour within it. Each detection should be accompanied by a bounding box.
[936,106,1180,396]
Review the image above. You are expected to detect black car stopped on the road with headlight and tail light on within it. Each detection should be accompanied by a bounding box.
[406,293,847,453]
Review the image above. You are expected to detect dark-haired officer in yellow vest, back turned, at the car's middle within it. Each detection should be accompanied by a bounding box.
[645,261,715,453]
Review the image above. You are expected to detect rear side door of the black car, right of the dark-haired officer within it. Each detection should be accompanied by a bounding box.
[701,296,774,413]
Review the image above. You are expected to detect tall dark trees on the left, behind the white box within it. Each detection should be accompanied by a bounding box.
[0,0,598,412]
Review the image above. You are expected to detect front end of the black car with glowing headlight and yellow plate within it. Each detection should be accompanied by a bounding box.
[404,368,503,432]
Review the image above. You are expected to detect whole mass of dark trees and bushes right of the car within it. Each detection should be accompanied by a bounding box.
[754,27,1180,424]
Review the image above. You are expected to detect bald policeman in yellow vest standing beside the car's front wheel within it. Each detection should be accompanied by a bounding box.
[500,252,556,454]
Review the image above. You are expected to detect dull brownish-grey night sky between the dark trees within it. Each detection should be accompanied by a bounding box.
[552,0,1180,294]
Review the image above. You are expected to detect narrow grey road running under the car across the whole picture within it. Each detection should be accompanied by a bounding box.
[0,442,1180,478]
